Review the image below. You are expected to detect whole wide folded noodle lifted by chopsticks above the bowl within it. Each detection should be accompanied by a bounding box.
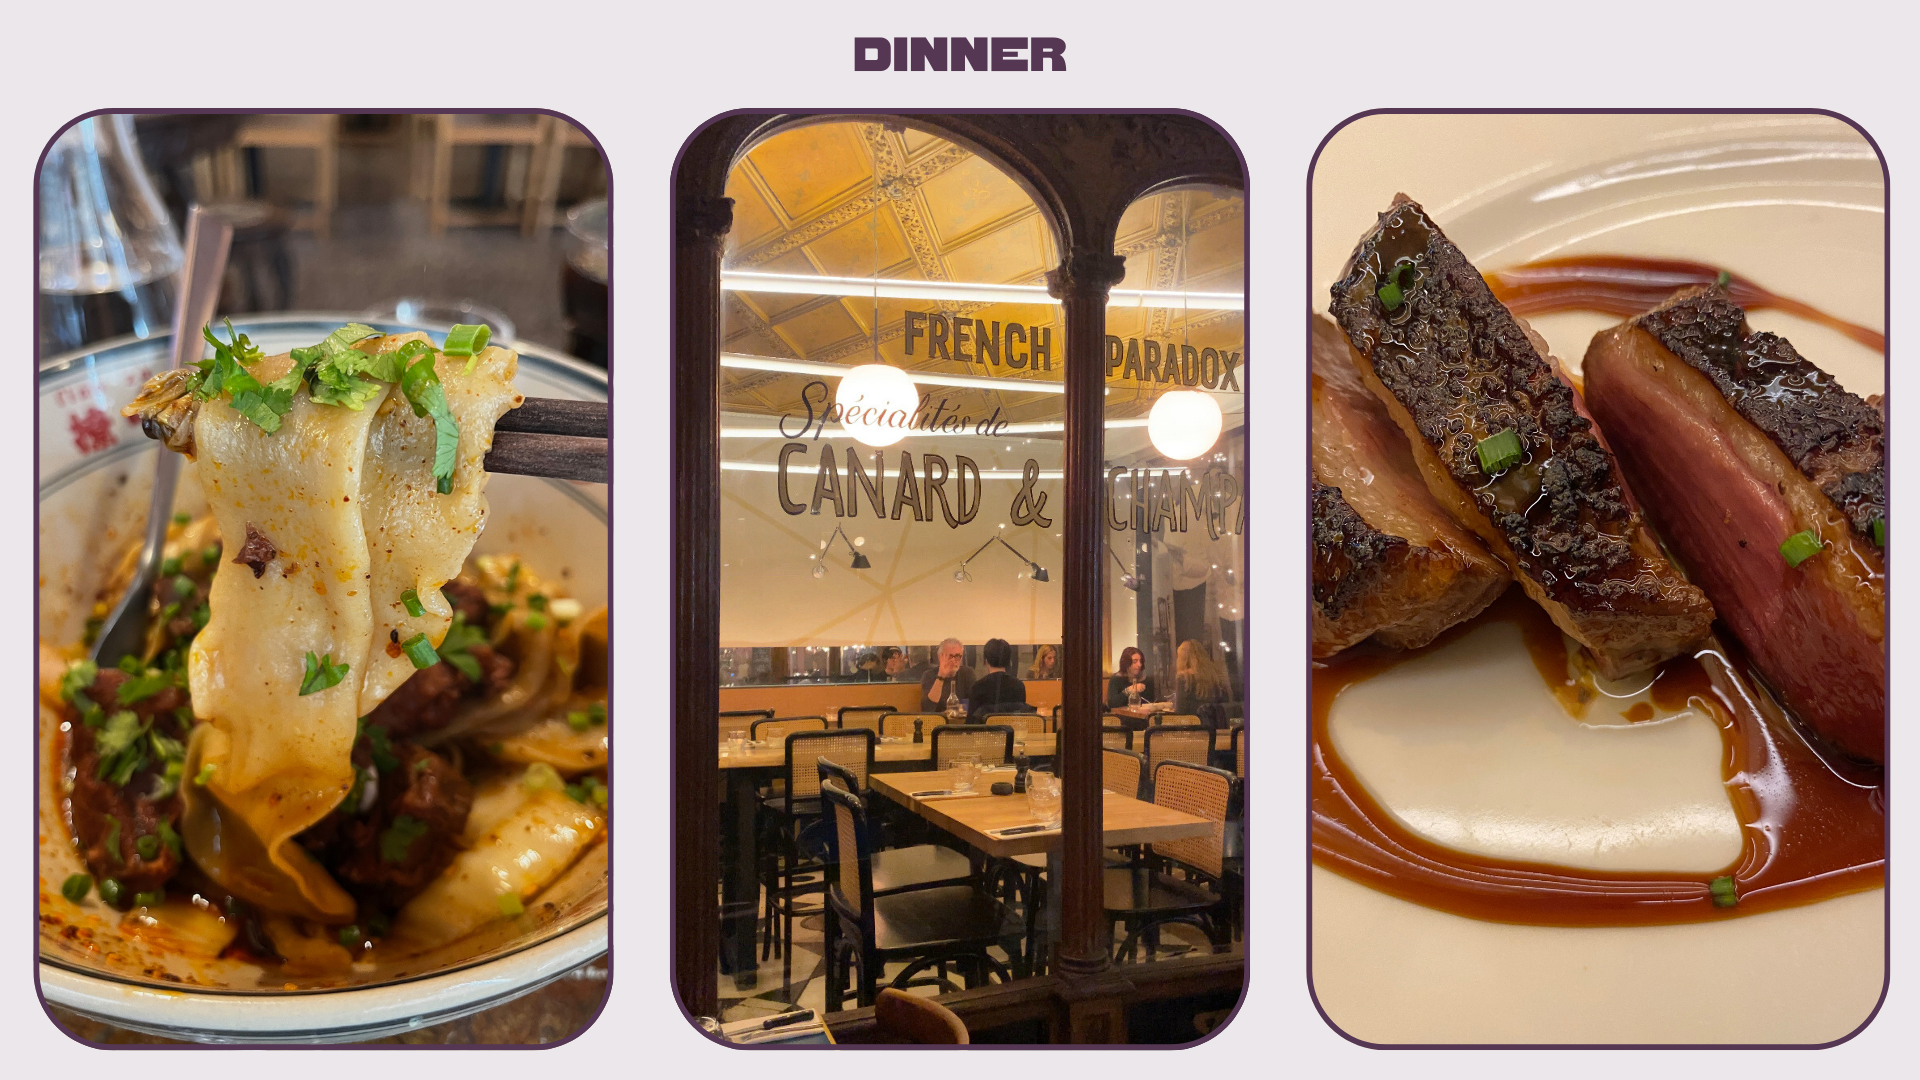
[182,334,522,922]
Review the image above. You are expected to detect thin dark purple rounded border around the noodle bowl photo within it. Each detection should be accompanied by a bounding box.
[25,108,618,1049]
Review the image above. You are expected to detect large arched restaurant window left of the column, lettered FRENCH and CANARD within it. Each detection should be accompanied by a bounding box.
[716,121,1067,1022]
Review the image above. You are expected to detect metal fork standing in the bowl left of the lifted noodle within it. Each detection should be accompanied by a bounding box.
[92,206,234,667]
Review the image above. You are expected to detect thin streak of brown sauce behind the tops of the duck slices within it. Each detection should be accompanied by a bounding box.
[1484,256,1887,352]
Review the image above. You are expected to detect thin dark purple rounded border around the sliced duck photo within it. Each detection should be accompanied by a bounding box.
[1300,108,1893,1049]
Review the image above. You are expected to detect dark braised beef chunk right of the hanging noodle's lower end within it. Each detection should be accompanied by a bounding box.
[300,744,472,909]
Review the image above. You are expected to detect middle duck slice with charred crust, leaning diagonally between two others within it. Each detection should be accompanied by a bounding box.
[1332,196,1713,678]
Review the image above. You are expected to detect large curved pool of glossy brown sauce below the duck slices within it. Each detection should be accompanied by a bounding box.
[1311,588,1885,926]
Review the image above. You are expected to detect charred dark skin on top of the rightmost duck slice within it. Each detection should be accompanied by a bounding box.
[1634,284,1887,540]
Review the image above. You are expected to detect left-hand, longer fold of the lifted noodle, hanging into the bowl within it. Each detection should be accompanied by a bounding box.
[188,356,388,919]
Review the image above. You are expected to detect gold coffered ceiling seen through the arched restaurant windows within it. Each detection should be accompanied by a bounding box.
[722,123,1246,419]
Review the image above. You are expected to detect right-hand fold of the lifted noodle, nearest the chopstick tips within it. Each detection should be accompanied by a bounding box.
[357,332,524,715]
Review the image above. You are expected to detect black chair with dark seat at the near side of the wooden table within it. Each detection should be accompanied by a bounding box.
[820,778,1023,1013]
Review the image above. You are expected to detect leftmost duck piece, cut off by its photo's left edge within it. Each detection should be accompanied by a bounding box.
[1313,315,1509,657]
